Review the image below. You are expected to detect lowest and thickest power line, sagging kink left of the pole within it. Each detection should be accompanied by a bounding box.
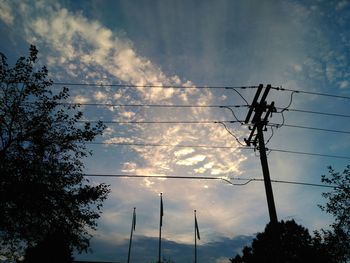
[83,174,335,188]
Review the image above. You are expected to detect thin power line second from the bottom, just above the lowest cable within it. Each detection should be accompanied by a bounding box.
[87,142,350,160]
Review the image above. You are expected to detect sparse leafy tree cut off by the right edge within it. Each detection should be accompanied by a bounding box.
[316,165,350,262]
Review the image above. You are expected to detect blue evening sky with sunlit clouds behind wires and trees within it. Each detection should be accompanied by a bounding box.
[0,0,350,263]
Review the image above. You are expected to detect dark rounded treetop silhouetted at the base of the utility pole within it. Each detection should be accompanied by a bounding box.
[230,220,332,263]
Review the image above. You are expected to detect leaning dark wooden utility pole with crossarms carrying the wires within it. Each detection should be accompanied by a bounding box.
[244,84,278,226]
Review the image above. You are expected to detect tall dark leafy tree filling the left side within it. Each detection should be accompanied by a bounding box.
[0,46,109,257]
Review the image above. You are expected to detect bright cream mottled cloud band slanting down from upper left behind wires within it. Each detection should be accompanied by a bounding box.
[0,1,254,241]
